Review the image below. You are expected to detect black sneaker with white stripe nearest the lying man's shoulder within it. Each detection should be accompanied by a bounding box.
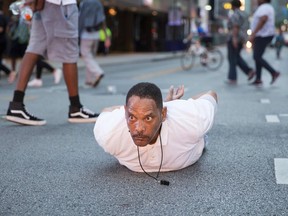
[68,106,99,123]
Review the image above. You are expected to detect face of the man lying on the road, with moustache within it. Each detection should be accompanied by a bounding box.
[125,96,167,146]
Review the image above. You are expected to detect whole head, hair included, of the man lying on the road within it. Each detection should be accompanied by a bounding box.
[125,82,167,146]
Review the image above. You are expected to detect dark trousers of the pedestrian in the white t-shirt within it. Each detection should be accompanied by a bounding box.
[253,36,276,80]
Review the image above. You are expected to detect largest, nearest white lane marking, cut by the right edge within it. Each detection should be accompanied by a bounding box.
[274,158,288,184]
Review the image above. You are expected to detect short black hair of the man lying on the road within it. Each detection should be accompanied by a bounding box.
[126,82,163,110]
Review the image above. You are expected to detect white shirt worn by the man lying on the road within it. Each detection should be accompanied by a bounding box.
[94,95,217,172]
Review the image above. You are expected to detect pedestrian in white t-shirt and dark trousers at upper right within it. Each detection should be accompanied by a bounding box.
[249,0,280,86]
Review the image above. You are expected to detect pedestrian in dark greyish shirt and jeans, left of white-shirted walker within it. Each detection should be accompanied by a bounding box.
[227,0,255,85]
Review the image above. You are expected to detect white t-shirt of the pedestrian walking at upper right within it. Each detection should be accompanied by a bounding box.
[251,3,275,37]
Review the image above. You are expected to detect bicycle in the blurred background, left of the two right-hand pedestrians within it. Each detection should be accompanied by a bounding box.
[181,41,224,70]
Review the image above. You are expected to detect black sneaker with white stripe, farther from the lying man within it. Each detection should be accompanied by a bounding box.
[6,101,46,125]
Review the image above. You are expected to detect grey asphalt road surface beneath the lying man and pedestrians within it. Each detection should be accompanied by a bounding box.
[0,44,288,216]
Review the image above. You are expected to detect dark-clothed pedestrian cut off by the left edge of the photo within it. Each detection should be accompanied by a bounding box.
[0,10,16,84]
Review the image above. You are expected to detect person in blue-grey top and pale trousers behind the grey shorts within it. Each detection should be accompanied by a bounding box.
[79,0,111,87]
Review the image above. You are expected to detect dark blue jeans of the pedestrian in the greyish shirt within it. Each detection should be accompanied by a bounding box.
[227,39,252,81]
